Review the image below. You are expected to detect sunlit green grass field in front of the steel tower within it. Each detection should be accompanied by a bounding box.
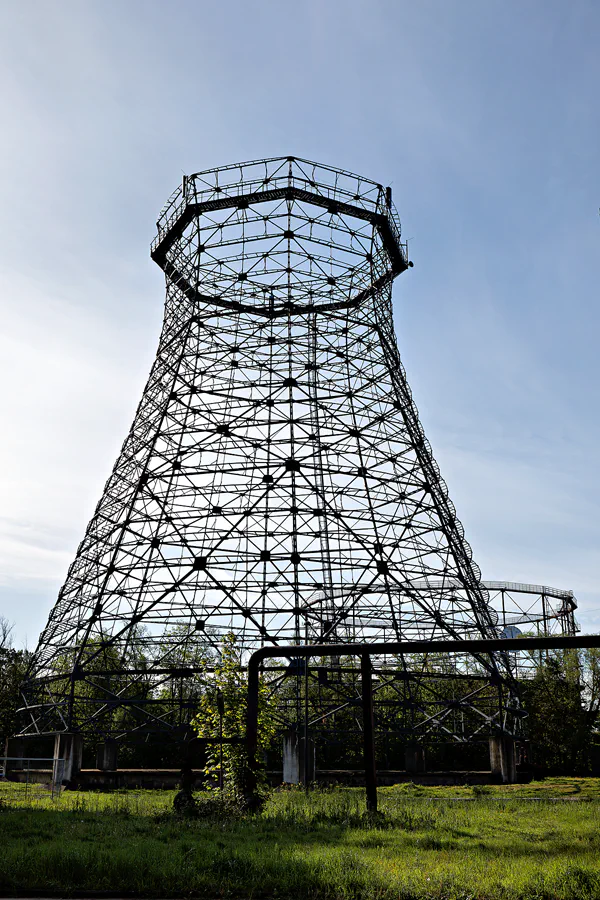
[0,778,600,900]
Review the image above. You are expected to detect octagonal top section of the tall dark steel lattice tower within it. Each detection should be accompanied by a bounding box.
[151,156,409,317]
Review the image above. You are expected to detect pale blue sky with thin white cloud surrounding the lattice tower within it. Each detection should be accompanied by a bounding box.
[0,0,600,646]
